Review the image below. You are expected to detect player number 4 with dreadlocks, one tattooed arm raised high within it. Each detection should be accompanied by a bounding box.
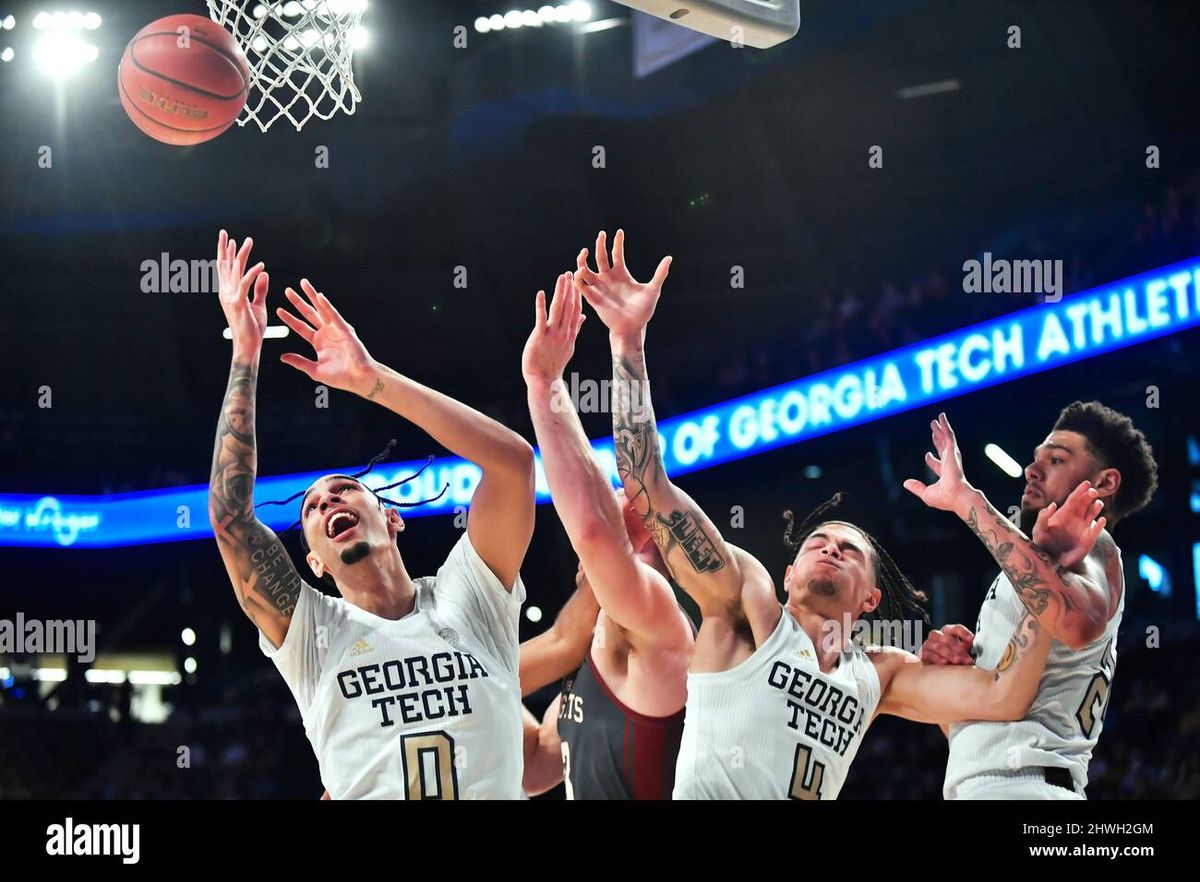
[575,230,1046,799]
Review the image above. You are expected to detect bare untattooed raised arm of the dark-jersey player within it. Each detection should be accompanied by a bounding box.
[522,272,691,649]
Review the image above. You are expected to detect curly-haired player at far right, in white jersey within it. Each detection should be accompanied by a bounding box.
[905,401,1158,799]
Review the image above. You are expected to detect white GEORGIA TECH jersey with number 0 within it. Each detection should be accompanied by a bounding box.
[259,533,524,799]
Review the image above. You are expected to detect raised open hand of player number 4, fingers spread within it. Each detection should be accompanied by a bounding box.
[575,229,671,335]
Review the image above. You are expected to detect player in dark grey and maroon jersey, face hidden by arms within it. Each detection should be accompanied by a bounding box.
[521,272,692,799]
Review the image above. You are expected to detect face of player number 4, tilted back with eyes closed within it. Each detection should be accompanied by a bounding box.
[785,522,880,618]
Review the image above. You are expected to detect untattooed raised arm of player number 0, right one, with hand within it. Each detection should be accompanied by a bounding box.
[278,280,534,590]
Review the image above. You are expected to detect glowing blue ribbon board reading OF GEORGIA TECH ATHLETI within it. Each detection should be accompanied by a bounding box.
[7,252,1200,548]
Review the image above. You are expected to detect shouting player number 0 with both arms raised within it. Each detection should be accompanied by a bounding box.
[209,230,534,799]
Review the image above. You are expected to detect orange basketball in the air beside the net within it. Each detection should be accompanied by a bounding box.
[116,16,250,146]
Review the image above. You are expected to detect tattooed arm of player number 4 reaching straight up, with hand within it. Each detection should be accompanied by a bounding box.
[576,230,781,640]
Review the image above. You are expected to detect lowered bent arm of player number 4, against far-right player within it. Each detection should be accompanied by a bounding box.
[869,612,1051,725]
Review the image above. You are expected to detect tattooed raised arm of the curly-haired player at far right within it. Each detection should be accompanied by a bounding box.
[904,414,1122,649]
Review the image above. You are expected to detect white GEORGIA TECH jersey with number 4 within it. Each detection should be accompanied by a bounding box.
[673,610,880,799]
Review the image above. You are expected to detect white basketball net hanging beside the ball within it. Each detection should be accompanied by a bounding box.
[208,0,367,132]
